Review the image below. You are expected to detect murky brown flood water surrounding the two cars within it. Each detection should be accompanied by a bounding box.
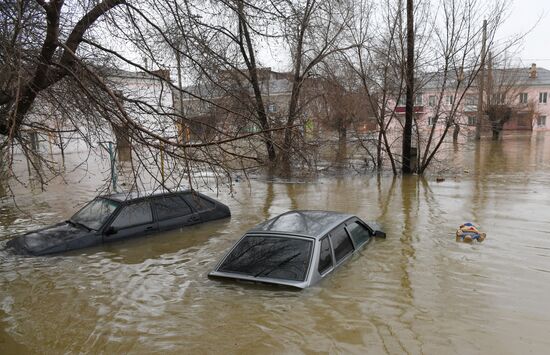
[0,133,550,354]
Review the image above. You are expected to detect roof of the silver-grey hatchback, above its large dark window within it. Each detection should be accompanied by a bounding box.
[247,210,355,239]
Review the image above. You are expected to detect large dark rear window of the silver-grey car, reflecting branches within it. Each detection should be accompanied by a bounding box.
[218,236,313,281]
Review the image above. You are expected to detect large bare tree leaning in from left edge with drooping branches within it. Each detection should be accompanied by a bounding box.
[0,0,286,195]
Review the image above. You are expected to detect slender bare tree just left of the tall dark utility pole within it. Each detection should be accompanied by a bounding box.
[342,0,405,174]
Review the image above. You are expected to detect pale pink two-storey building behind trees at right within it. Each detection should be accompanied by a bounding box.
[395,64,550,134]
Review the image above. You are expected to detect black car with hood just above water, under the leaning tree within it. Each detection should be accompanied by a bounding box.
[7,190,231,255]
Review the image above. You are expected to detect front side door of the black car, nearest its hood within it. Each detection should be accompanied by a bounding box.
[103,201,158,241]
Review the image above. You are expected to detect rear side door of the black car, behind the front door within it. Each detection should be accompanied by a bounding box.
[153,195,200,230]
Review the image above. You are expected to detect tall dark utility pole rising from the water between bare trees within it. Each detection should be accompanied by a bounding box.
[401,0,414,174]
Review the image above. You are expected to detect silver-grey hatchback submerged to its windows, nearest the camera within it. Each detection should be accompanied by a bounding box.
[209,211,386,288]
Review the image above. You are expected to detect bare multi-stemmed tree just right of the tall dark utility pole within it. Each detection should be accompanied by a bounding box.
[418,0,506,173]
